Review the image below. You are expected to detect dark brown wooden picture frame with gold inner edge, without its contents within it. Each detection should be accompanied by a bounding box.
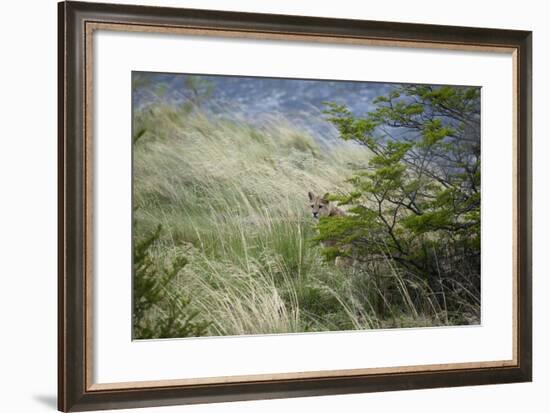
[58,1,532,411]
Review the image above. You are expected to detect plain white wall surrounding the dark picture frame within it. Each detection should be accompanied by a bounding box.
[0,0,550,413]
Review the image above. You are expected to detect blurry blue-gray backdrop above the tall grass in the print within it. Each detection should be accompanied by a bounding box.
[133,72,474,143]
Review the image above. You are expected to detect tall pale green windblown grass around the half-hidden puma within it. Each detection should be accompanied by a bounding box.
[133,104,470,335]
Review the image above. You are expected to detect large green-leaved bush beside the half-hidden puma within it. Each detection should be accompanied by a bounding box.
[317,85,480,314]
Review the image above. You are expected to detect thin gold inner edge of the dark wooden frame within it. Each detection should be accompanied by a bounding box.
[84,20,520,392]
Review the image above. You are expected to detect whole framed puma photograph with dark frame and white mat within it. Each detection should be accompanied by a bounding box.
[59,1,532,411]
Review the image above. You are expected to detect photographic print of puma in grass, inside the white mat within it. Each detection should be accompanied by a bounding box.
[132,72,481,339]
